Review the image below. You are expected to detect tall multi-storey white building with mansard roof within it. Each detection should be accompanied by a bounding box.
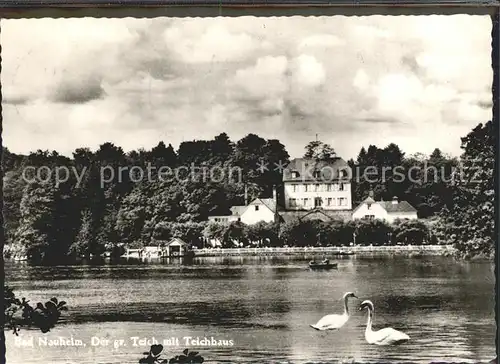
[283,157,352,211]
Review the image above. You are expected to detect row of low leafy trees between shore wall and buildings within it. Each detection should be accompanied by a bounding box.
[200,219,439,248]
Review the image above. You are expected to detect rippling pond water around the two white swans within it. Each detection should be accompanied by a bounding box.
[5,256,496,364]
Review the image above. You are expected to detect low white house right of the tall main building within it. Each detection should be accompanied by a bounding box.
[352,192,418,223]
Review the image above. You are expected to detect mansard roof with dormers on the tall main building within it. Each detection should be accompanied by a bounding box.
[283,157,352,182]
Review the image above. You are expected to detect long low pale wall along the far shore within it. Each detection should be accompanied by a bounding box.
[195,245,455,257]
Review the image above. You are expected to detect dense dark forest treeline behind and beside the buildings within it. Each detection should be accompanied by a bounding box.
[2,122,496,260]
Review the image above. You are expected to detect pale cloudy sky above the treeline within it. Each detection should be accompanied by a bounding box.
[1,15,492,159]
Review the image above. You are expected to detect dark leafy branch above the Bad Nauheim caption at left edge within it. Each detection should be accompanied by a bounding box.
[4,286,68,335]
